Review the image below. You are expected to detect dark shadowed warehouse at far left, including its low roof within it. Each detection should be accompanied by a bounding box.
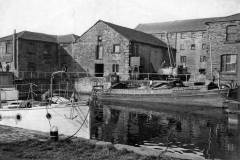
[0,31,78,79]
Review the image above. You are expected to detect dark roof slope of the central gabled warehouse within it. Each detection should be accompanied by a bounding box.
[100,20,167,47]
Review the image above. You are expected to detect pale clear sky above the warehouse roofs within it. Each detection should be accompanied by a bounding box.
[0,0,240,37]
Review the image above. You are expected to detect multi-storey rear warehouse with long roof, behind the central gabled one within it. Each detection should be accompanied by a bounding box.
[136,18,218,75]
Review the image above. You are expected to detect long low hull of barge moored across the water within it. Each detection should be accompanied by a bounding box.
[98,89,228,107]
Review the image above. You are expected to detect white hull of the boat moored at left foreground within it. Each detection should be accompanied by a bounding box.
[0,104,90,138]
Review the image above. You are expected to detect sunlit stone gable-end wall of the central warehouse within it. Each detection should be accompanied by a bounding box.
[73,21,129,80]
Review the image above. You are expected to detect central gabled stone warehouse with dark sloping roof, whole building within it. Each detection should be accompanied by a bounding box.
[70,20,175,80]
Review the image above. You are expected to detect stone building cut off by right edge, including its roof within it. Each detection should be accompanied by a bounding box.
[206,14,240,84]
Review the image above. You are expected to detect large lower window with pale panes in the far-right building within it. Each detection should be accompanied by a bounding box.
[221,54,237,73]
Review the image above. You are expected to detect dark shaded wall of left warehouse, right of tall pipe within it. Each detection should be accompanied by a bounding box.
[18,39,59,72]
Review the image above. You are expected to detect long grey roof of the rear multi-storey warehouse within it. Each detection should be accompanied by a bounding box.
[135,18,217,33]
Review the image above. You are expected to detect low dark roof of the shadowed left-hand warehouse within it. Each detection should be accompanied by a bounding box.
[0,31,78,43]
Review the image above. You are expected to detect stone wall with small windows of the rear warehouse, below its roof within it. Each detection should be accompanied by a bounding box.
[153,30,208,75]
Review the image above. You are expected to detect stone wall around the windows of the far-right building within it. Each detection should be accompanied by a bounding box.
[207,21,240,83]
